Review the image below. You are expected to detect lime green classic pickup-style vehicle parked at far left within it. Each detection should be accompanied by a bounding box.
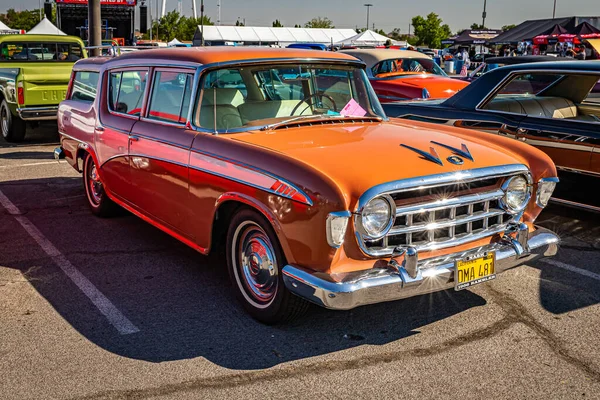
[0,35,87,142]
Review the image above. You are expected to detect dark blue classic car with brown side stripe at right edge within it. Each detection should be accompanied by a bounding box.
[384,61,600,211]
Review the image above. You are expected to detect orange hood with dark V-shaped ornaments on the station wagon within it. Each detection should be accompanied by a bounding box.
[231,121,524,204]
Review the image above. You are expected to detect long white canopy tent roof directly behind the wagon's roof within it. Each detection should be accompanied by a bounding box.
[194,25,356,46]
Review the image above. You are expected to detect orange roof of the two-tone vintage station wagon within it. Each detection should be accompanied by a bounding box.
[78,46,362,67]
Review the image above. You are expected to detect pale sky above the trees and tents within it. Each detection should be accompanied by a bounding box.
[0,0,600,33]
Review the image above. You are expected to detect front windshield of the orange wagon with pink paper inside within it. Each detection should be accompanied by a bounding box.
[195,64,385,132]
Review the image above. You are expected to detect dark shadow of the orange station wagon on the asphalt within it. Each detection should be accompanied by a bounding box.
[0,178,486,370]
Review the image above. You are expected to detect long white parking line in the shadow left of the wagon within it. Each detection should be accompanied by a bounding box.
[0,191,140,335]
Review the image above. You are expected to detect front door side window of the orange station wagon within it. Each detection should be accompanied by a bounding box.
[148,71,194,124]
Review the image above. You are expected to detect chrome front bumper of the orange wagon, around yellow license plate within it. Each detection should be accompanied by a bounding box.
[283,227,560,310]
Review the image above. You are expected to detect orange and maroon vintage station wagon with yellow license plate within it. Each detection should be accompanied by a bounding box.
[55,48,559,323]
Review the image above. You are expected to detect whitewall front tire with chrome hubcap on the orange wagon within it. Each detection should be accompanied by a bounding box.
[227,209,309,324]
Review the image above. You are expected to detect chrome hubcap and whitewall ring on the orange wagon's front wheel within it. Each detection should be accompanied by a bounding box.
[237,222,278,305]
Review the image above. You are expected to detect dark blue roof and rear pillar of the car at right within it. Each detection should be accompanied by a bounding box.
[443,61,600,109]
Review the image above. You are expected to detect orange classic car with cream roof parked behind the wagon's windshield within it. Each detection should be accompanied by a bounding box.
[341,49,468,103]
